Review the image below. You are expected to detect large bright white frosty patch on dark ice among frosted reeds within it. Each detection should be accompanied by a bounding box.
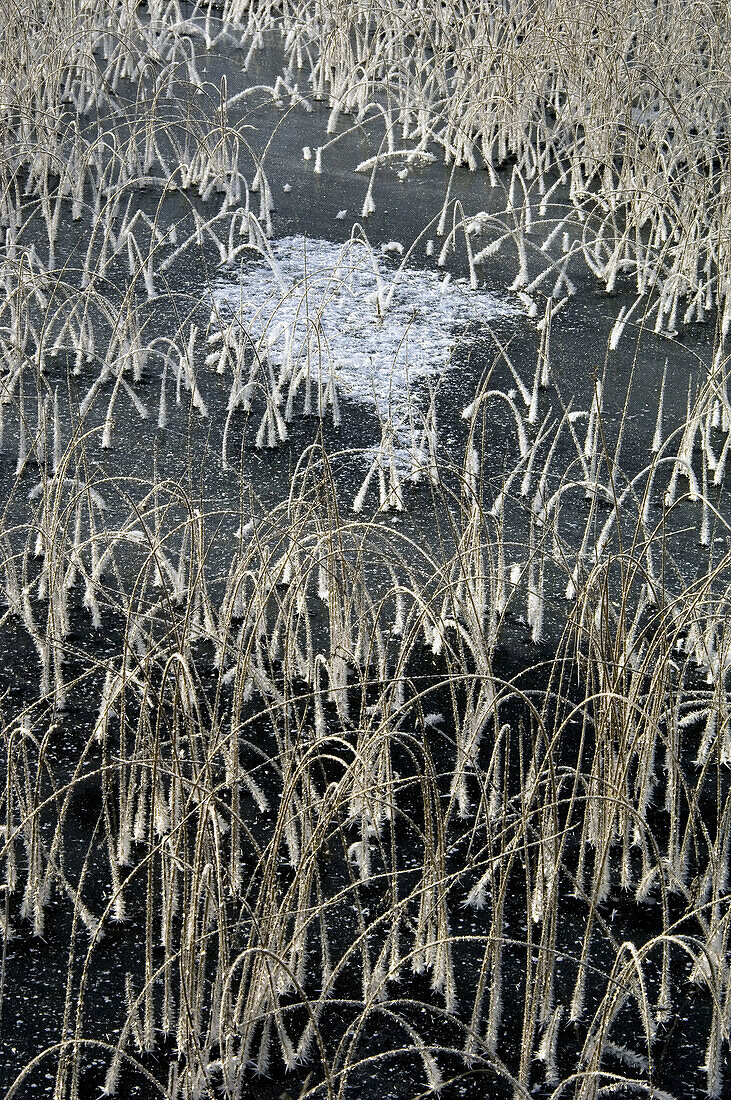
[213,237,522,440]
